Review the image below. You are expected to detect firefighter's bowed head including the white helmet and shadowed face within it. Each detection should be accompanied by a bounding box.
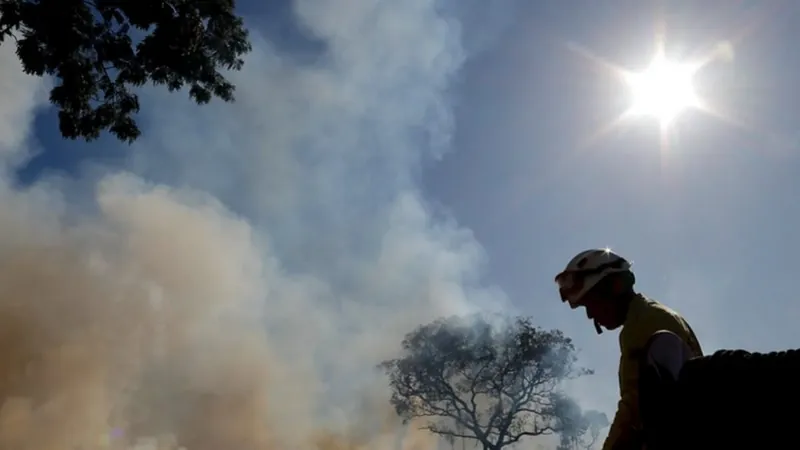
[555,249,636,333]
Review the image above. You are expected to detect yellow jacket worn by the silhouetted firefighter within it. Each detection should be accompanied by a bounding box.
[603,294,703,450]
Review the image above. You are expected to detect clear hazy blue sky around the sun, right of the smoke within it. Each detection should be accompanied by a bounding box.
[427,2,800,412]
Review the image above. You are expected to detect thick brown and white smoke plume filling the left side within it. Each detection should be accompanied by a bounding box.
[0,0,520,450]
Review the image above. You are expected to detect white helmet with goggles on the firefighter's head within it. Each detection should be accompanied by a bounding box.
[555,248,631,309]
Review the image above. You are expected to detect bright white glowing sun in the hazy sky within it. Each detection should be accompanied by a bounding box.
[625,53,700,127]
